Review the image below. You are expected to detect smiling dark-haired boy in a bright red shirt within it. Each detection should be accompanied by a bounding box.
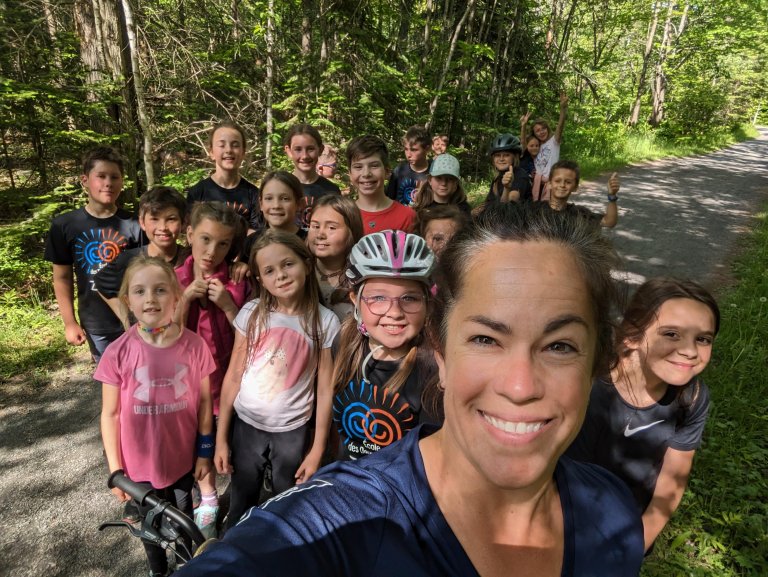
[347,135,416,234]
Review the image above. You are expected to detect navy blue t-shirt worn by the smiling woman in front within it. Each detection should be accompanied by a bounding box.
[177,426,643,577]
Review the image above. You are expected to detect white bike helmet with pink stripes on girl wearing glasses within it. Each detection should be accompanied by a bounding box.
[346,230,435,285]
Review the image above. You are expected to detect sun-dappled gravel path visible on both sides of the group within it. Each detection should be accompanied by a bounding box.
[0,129,768,577]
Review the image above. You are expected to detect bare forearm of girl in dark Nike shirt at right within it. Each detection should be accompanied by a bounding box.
[643,447,696,551]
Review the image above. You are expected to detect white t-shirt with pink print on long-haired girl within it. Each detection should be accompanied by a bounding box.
[234,299,340,433]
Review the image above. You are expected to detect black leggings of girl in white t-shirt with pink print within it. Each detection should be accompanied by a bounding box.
[227,413,309,529]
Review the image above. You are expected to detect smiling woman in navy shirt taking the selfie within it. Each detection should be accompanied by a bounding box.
[181,204,643,576]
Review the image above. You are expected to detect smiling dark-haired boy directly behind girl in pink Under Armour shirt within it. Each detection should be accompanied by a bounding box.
[94,186,189,321]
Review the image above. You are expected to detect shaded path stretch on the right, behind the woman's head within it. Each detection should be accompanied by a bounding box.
[574,128,768,288]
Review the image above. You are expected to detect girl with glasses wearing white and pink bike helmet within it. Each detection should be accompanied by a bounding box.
[332,230,438,460]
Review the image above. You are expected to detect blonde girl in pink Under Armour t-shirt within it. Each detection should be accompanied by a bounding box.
[94,255,216,575]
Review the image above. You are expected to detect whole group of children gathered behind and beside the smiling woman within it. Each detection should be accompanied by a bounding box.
[46,107,717,575]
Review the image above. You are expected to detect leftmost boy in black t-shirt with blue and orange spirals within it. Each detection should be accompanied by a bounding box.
[45,147,141,362]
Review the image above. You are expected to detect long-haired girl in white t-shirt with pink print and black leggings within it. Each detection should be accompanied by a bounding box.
[214,229,339,528]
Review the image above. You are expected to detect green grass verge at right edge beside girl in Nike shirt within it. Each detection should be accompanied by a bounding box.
[642,205,768,577]
